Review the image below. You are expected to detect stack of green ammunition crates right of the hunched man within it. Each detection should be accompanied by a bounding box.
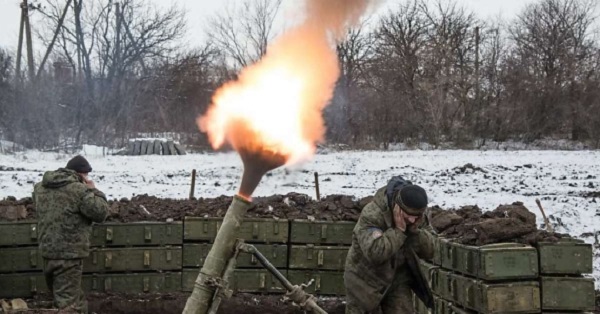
[414,238,595,314]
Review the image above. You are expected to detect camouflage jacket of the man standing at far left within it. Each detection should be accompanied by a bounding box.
[33,168,108,259]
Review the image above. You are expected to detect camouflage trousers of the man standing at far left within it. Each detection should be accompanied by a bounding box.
[44,259,88,313]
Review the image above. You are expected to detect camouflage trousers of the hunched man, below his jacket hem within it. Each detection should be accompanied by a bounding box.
[346,285,415,314]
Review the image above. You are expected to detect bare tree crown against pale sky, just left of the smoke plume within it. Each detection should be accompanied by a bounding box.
[208,0,282,69]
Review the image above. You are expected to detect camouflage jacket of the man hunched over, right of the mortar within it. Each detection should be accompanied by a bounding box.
[344,183,433,311]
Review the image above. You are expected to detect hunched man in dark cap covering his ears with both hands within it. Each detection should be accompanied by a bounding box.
[344,176,433,314]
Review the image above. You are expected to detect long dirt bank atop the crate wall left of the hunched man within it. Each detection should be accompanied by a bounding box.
[0,193,372,222]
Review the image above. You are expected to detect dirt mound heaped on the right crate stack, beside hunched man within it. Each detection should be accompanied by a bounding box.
[431,202,568,245]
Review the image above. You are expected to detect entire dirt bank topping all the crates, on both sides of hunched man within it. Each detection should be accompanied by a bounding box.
[0,193,568,245]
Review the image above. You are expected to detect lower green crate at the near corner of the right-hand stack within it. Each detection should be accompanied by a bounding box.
[450,274,541,314]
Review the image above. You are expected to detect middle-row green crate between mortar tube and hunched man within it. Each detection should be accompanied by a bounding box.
[289,244,350,270]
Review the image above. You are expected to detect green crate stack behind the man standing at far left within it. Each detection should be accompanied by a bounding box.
[0,222,182,298]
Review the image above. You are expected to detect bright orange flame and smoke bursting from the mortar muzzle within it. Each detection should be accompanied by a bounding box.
[197,0,370,164]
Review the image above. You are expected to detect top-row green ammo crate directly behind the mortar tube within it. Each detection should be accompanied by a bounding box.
[183,217,289,243]
